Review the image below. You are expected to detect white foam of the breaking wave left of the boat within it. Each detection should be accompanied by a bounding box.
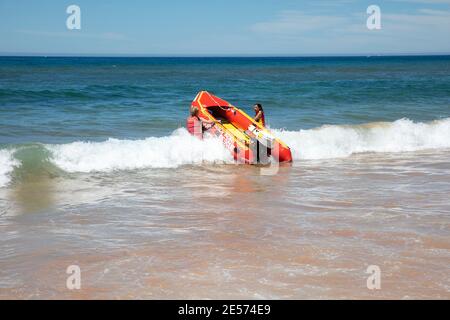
[46,129,232,172]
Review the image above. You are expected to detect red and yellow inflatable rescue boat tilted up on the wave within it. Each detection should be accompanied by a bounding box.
[191,91,292,164]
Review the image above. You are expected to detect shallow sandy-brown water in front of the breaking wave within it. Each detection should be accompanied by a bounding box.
[0,150,450,299]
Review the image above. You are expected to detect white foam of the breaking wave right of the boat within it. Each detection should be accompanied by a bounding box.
[273,118,450,160]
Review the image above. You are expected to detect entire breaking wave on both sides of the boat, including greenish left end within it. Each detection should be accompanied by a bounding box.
[0,118,450,181]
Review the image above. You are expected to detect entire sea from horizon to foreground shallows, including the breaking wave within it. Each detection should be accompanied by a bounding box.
[0,56,450,299]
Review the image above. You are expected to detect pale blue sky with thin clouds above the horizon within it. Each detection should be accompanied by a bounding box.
[0,0,450,56]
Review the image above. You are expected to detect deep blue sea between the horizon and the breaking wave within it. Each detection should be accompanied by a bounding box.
[0,56,450,144]
